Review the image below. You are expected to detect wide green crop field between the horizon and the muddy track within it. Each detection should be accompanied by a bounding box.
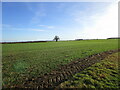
[2,39,118,87]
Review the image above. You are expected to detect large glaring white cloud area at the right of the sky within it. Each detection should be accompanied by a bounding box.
[78,3,118,39]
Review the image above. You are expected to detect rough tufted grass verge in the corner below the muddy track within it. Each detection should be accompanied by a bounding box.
[59,52,120,90]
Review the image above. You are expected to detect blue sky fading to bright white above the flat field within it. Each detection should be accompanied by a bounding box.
[2,2,118,41]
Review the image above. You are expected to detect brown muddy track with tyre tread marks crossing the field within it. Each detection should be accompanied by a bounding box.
[20,49,120,88]
